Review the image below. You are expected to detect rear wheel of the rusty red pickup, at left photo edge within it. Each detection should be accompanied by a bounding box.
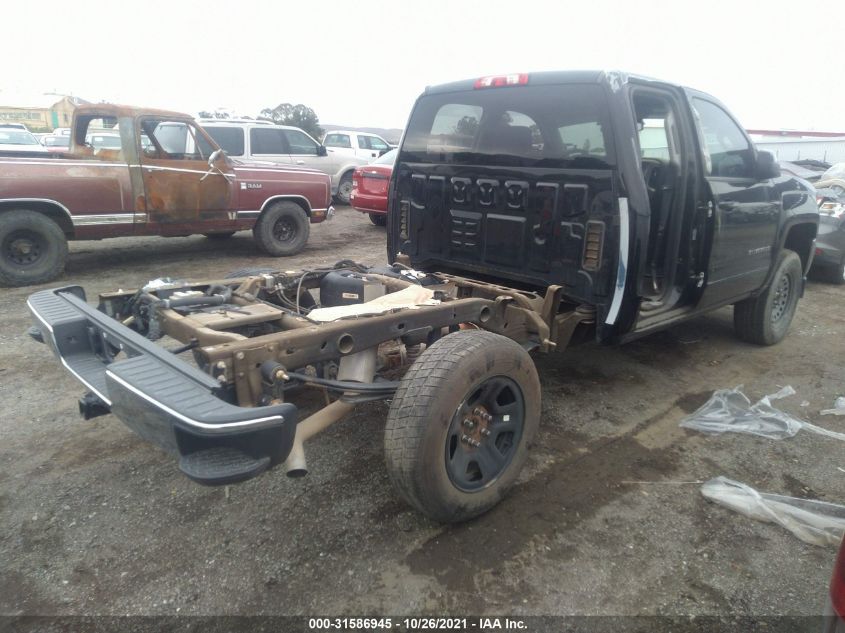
[0,209,67,286]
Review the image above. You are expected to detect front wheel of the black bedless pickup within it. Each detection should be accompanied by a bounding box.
[734,249,804,345]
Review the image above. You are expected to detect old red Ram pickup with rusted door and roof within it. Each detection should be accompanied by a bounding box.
[0,104,334,286]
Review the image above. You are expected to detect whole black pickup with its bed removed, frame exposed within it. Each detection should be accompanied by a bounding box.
[29,72,818,521]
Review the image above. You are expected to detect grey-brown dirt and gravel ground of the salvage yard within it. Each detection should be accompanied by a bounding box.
[0,208,845,616]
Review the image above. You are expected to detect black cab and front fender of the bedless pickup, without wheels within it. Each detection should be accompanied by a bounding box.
[389,72,818,342]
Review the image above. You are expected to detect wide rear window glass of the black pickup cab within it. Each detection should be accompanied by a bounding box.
[402,84,614,169]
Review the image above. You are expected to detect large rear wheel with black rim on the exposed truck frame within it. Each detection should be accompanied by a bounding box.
[384,330,540,523]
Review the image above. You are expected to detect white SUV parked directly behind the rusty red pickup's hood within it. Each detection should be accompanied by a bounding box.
[199,119,368,204]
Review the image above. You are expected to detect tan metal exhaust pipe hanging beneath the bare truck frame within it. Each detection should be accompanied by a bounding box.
[285,347,378,477]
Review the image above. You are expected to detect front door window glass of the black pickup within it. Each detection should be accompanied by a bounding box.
[693,98,754,178]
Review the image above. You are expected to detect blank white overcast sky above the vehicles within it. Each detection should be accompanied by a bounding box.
[0,0,845,131]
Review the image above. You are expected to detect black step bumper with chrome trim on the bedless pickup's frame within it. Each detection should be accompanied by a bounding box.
[27,286,297,485]
